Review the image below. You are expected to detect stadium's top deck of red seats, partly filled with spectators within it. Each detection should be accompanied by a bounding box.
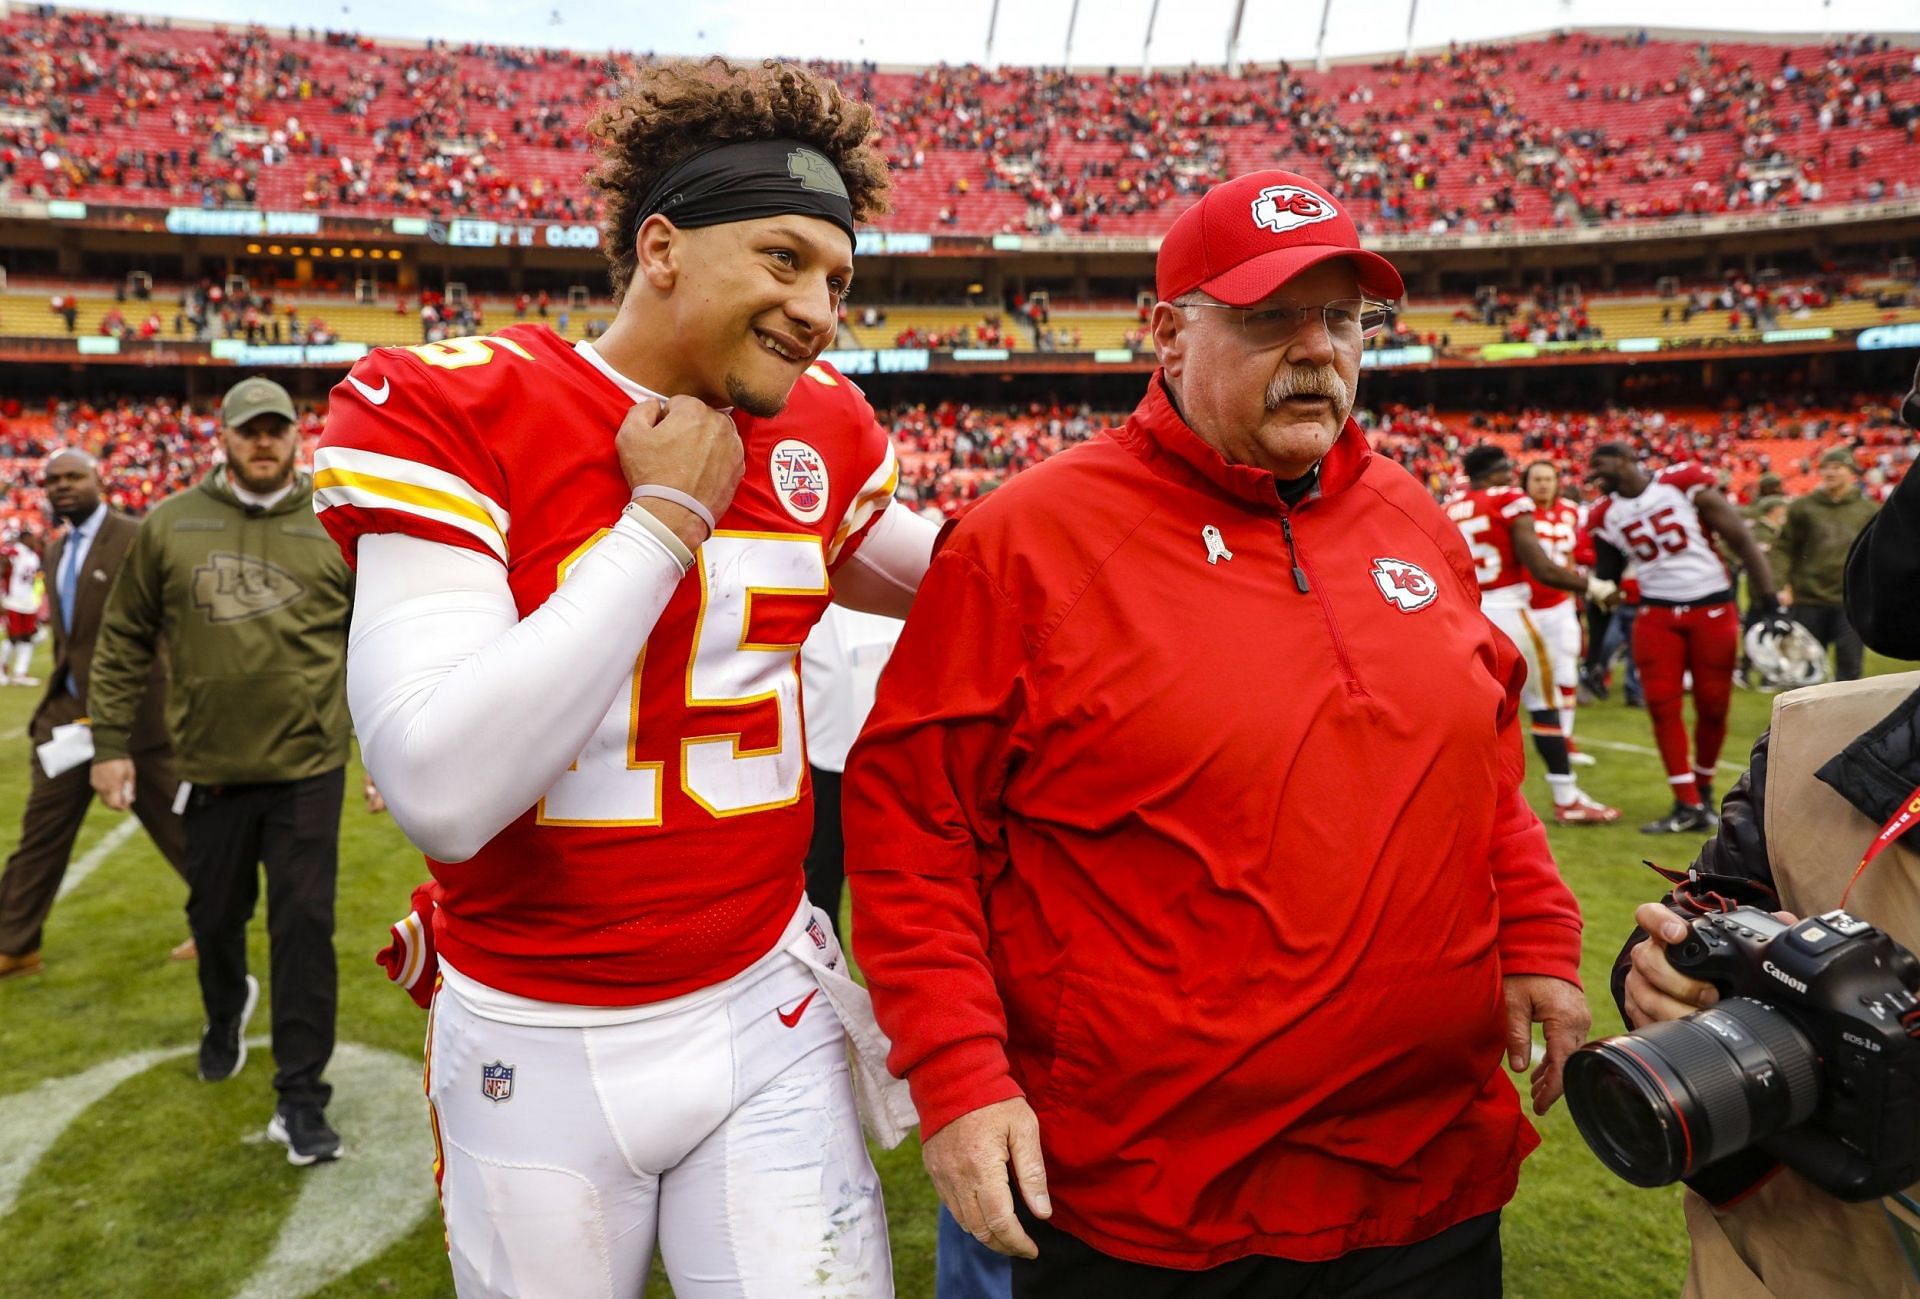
[0,8,1920,234]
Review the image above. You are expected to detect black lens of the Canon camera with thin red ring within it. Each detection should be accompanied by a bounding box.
[1567,998,1820,1186]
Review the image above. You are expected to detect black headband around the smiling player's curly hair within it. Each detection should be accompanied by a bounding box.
[626,140,854,244]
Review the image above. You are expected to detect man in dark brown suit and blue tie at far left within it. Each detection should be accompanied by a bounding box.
[0,449,192,979]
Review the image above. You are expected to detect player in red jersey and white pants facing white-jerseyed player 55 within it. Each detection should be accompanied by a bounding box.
[1446,445,1620,825]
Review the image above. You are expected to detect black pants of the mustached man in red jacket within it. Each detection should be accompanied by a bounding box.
[1014,1195,1501,1299]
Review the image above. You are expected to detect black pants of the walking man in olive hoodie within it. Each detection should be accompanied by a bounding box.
[186,768,346,1107]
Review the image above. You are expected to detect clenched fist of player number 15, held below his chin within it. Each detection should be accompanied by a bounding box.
[614,397,747,551]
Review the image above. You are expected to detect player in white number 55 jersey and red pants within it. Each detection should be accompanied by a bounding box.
[1588,441,1778,835]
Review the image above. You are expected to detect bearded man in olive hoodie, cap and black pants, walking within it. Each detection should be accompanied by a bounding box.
[90,376,353,1165]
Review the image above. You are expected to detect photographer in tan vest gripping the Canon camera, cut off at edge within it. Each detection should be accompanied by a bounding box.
[1613,354,1920,1299]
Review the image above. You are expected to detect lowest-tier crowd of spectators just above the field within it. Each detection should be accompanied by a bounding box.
[0,385,1920,531]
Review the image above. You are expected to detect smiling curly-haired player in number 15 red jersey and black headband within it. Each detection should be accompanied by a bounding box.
[315,59,937,1299]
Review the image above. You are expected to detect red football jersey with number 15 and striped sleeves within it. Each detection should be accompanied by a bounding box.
[313,324,899,1005]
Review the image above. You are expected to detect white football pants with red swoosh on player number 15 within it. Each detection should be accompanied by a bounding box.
[426,952,893,1299]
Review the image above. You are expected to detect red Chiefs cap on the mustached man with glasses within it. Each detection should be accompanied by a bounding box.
[1154,171,1407,307]
